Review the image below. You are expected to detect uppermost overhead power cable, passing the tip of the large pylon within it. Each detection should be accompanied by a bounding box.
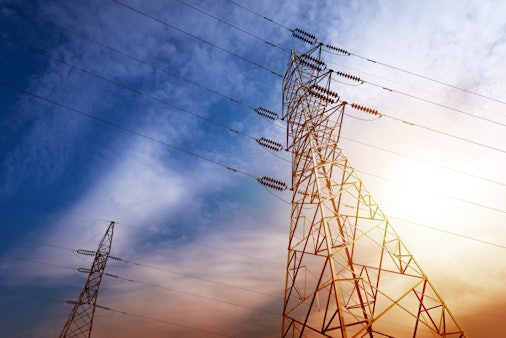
[224,0,506,104]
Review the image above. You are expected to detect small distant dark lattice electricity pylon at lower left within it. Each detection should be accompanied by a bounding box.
[60,222,115,338]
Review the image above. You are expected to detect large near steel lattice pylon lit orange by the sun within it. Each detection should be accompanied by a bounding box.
[282,45,466,337]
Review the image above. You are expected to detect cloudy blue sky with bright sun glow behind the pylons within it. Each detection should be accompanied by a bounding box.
[0,0,506,338]
